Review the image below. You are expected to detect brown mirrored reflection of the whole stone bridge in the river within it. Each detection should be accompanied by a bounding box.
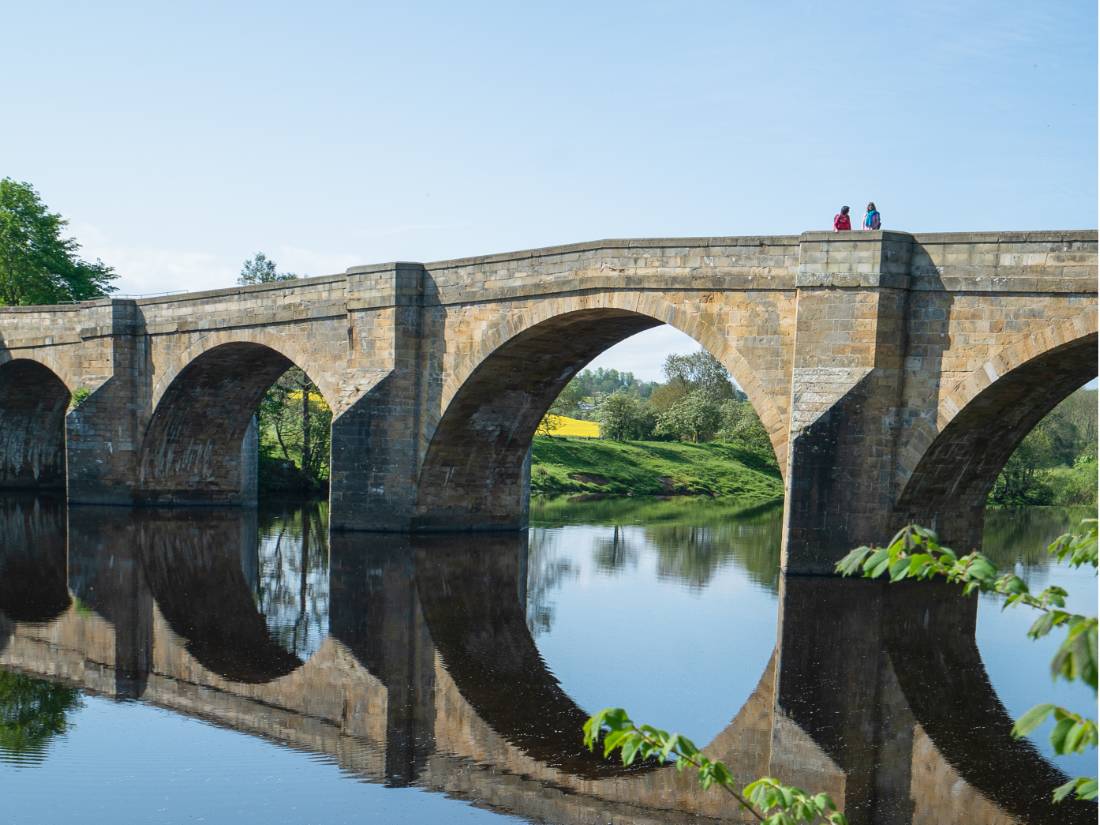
[0,498,1096,824]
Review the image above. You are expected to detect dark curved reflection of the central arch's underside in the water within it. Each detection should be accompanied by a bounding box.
[413,534,659,779]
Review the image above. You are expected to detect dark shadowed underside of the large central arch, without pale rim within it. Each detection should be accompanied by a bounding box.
[413,307,784,531]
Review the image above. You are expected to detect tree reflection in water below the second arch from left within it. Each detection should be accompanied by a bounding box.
[255,502,329,661]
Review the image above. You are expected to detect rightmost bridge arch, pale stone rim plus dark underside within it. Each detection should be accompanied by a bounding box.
[895,323,1098,549]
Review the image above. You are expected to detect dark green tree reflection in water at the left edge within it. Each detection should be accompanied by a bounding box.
[0,670,80,754]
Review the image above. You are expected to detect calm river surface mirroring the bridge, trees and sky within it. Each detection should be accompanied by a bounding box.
[0,497,1096,824]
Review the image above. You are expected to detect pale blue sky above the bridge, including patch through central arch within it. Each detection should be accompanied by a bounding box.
[0,0,1097,377]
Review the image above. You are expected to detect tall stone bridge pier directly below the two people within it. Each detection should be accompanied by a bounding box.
[782,232,913,573]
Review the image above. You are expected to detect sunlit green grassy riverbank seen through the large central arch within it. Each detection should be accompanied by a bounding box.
[531,437,783,507]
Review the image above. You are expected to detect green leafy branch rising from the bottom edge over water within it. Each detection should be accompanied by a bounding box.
[584,707,848,825]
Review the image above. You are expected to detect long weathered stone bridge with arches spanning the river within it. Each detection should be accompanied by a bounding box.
[0,231,1097,572]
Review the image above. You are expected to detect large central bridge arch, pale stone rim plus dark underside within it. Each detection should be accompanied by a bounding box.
[415,293,787,529]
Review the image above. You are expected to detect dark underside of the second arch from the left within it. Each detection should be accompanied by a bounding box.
[136,340,323,504]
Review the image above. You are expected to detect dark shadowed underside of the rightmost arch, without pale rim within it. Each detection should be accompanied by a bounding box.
[894,332,1097,549]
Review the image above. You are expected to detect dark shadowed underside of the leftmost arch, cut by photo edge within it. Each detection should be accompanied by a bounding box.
[0,359,72,490]
